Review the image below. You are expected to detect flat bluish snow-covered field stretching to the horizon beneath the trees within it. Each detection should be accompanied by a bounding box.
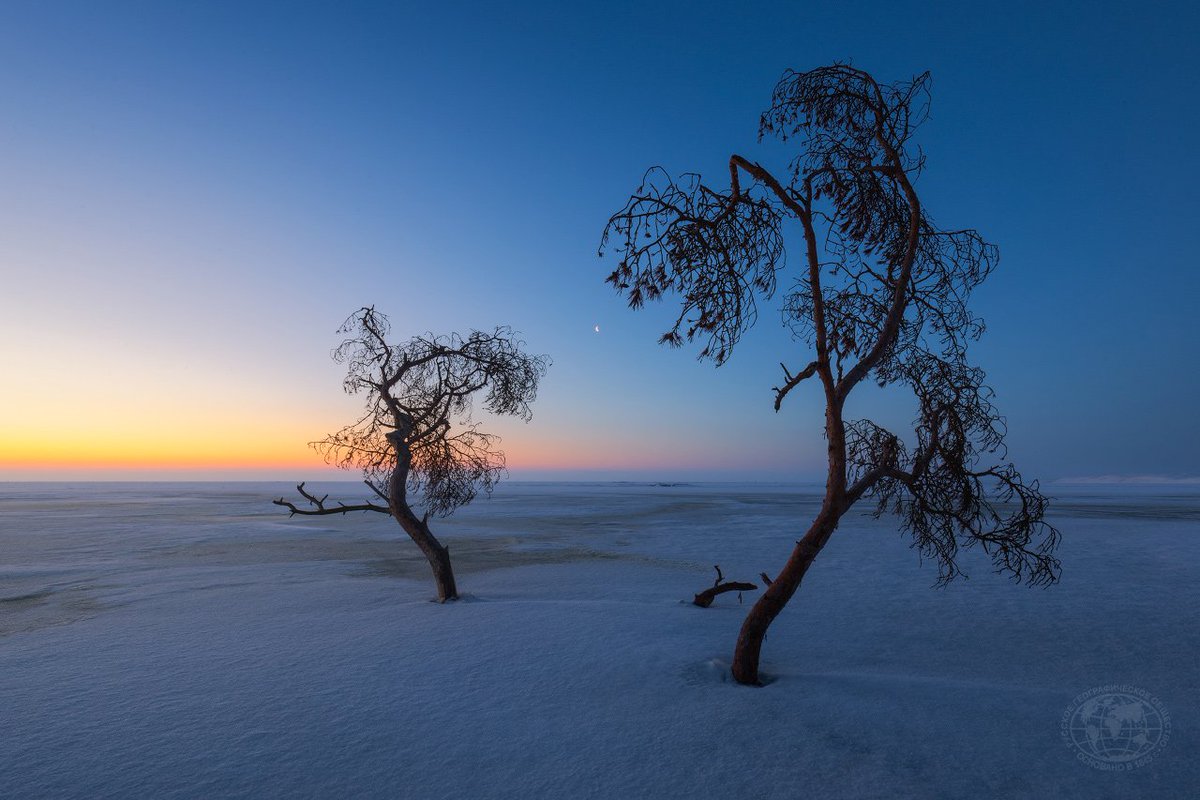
[0,482,1200,800]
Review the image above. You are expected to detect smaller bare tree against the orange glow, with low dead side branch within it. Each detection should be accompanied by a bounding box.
[275,307,550,602]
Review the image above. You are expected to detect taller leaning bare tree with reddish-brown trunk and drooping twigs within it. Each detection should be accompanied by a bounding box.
[600,64,1058,684]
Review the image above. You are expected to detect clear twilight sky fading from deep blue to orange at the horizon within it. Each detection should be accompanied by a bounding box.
[0,0,1200,480]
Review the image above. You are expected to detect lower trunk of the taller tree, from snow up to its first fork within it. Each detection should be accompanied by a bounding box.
[733,506,841,686]
